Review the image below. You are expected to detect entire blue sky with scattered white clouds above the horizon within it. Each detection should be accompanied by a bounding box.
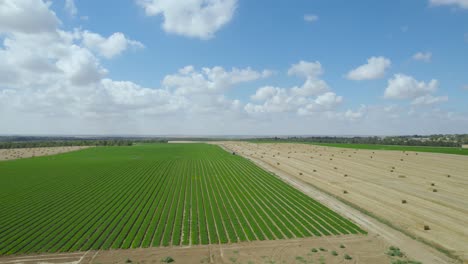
[0,0,468,135]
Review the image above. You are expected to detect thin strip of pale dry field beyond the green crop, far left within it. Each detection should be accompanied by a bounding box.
[0,146,90,161]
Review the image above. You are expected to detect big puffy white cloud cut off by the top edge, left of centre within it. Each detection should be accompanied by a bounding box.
[136,0,237,39]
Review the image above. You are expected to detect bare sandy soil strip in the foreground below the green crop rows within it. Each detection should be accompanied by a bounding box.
[0,236,407,264]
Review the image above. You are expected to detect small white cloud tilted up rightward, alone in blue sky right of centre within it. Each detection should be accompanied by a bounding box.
[346,57,391,80]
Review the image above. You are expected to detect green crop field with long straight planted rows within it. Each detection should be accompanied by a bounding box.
[0,144,365,255]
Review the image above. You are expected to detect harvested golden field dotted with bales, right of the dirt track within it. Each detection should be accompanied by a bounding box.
[221,142,468,261]
